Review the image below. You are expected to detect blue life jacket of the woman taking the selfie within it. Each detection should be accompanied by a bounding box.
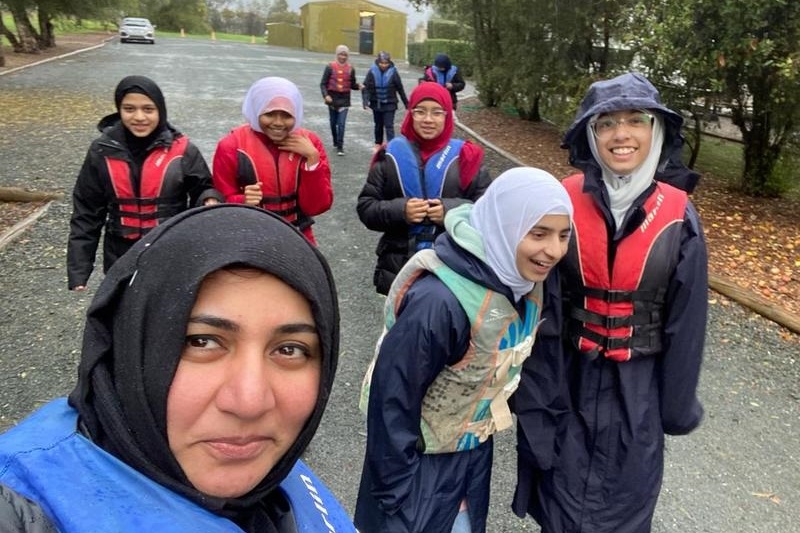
[0,398,355,533]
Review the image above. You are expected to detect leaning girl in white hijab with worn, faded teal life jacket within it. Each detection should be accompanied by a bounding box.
[355,167,572,533]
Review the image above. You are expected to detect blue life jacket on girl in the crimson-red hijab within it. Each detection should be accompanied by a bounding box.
[386,135,464,251]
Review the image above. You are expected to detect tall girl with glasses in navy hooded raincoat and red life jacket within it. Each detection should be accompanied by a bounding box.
[514,73,707,533]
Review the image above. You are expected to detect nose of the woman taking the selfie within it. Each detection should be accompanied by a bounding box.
[216,348,275,419]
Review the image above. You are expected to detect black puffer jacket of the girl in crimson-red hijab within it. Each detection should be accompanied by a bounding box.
[356,143,491,294]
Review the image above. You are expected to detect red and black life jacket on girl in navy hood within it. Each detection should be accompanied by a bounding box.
[562,174,688,361]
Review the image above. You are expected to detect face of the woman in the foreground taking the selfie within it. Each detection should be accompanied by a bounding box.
[167,270,322,498]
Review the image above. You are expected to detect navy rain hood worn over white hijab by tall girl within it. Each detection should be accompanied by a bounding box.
[561,72,699,192]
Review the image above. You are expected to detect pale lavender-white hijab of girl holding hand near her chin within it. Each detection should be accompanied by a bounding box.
[242,76,303,132]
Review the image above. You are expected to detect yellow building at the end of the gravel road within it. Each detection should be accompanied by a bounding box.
[300,0,408,60]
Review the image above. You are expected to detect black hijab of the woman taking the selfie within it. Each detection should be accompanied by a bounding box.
[69,204,339,531]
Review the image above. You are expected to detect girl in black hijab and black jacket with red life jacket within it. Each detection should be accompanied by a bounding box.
[67,76,222,291]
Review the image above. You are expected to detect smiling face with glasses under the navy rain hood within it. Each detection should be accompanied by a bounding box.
[595,109,653,176]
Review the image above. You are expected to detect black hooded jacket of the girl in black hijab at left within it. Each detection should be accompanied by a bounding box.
[67,115,219,289]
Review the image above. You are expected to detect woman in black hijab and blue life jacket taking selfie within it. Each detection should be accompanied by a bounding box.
[0,204,355,533]
